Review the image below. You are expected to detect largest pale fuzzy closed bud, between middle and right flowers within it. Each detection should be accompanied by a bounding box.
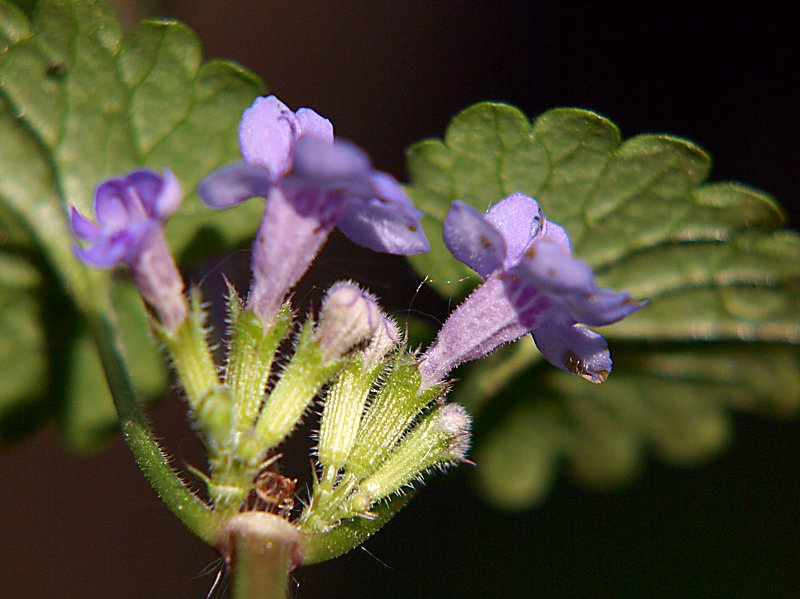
[317,281,381,362]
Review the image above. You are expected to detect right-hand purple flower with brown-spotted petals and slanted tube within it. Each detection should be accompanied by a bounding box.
[419,193,644,387]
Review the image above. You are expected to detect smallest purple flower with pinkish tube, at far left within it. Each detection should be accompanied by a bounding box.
[70,169,186,330]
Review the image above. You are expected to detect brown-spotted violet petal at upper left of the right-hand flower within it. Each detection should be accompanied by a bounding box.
[442,201,506,279]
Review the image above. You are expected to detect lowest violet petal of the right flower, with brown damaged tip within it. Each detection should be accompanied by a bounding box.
[533,318,611,383]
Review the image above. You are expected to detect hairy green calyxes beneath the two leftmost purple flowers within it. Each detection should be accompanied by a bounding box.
[158,289,298,514]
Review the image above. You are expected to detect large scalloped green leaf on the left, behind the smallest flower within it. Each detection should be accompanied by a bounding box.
[0,0,262,450]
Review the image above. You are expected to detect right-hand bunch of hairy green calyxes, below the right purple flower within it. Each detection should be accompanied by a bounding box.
[300,350,470,557]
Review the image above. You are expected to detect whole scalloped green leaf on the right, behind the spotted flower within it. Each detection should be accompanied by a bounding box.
[408,103,800,508]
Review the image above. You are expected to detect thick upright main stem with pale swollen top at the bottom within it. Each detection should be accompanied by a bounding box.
[217,512,303,599]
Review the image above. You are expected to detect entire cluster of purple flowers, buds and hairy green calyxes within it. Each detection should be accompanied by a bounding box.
[72,96,642,560]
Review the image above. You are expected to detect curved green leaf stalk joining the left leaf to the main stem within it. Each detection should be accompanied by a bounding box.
[84,309,221,544]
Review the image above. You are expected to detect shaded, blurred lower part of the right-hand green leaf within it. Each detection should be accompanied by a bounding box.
[474,343,800,509]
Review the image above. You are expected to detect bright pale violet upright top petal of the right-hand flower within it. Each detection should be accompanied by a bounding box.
[482,193,544,268]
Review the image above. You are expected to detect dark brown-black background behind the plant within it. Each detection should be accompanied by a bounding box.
[0,0,800,598]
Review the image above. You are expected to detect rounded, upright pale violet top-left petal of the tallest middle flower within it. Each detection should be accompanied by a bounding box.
[239,96,299,179]
